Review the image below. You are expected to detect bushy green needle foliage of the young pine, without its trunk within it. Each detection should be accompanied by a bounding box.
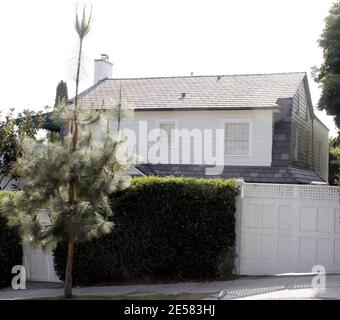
[2,108,135,244]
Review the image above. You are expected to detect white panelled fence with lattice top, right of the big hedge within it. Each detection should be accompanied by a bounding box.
[236,183,340,275]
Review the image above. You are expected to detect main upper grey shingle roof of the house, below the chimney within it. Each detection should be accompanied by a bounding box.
[79,72,306,110]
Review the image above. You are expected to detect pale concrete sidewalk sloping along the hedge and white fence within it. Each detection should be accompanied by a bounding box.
[0,274,340,300]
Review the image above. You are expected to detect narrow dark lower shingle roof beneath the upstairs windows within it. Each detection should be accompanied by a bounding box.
[137,163,323,184]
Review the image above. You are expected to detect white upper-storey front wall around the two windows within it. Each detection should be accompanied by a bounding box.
[115,110,273,166]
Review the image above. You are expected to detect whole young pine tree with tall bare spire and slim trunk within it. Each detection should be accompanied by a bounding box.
[1,7,132,298]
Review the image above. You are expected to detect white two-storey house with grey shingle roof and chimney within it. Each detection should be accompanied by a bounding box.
[72,55,328,184]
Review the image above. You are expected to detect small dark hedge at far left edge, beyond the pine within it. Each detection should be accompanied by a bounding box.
[0,191,23,288]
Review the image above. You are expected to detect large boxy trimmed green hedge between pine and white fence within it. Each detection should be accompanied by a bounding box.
[54,177,238,283]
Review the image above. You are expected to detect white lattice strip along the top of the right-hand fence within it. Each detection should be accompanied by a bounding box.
[242,183,340,200]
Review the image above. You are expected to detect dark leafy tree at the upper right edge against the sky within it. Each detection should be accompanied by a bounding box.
[313,0,340,129]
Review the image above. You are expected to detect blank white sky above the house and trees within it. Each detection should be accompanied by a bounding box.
[0,0,336,136]
